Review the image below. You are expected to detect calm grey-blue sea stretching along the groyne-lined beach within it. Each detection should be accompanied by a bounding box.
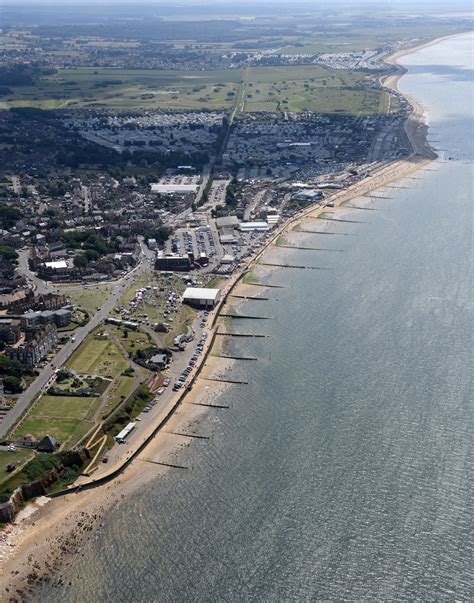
[38,36,474,602]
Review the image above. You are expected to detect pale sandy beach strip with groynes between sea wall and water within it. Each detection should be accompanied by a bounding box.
[0,36,453,600]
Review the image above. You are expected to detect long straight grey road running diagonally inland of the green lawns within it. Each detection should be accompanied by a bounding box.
[0,242,153,437]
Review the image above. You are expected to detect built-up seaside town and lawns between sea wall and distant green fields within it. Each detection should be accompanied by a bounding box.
[0,21,456,521]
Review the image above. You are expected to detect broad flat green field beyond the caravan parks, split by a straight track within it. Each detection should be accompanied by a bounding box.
[0,65,383,115]
